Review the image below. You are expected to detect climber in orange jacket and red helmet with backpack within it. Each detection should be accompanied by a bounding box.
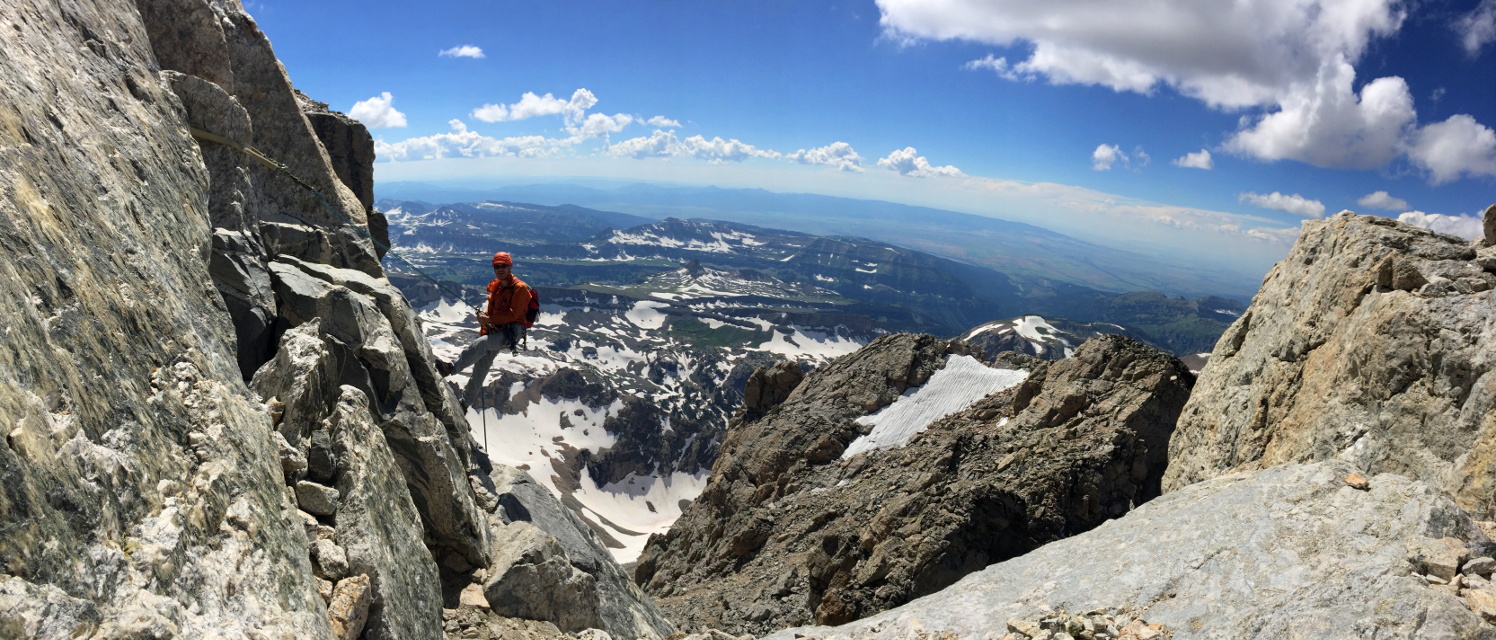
[438,251,534,405]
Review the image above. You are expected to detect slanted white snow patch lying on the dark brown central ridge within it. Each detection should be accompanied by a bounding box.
[841,354,1028,459]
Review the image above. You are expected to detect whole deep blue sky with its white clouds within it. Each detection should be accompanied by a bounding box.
[247,0,1496,278]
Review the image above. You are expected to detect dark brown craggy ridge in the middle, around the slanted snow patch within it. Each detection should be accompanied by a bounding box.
[636,335,1192,633]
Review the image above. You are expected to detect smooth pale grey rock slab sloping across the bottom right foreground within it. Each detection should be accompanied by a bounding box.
[767,461,1496,640]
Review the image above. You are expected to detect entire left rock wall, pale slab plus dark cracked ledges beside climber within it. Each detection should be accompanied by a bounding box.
[0,0,672,639]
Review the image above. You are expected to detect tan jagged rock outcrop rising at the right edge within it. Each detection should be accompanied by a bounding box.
[1164,212,1496,514]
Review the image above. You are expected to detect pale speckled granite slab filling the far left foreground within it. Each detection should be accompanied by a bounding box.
[0,1,331,639]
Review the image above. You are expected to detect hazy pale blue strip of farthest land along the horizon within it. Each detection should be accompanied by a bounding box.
[378,182,1261,302]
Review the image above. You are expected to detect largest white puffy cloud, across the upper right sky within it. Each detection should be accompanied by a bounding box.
[877,0,1496,182]
